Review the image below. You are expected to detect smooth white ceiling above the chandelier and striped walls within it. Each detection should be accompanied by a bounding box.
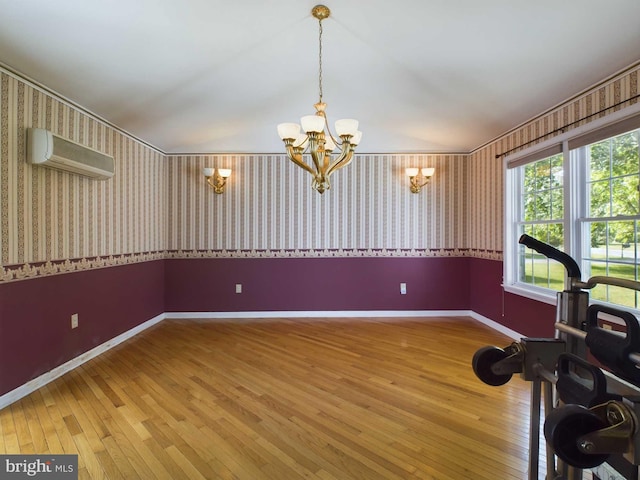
[0,0,640,153]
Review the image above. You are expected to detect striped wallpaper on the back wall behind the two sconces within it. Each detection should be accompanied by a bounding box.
[167,155,466,256]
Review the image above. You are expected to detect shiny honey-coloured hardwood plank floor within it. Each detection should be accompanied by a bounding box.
[0,318,540,480]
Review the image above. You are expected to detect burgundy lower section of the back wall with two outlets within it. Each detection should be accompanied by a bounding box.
[165,257,469,312]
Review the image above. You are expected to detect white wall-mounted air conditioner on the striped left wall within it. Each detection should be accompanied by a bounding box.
[27,128,115,180]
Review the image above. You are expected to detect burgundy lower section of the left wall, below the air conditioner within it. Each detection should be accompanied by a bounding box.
[0,260,164,395]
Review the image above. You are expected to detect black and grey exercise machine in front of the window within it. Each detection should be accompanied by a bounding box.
[472,235,640,480]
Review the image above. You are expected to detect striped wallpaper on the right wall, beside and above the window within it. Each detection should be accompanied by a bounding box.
[466,65,640,258]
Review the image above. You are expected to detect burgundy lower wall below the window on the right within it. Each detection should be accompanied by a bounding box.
[470,258,556,338]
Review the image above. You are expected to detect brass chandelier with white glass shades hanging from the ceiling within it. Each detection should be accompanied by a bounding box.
[278,5,362,193]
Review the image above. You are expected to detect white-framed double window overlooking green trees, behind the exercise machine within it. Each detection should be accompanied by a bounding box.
[505,110,640,309]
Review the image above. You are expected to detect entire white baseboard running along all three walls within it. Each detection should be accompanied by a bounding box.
[0,310,522,410]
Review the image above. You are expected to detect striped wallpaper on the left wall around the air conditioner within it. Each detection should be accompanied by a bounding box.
[0,70,166,281]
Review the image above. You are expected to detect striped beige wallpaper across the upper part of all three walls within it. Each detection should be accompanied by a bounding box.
[0,62,640,282]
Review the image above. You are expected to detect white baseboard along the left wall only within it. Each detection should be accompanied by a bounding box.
[0,313,165,410]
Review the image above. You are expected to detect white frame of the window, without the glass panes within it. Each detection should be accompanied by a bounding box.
[502,104,640,313]
